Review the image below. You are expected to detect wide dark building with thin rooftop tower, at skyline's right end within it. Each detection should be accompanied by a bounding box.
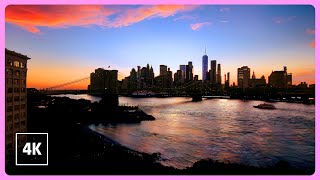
[268,66,292,88]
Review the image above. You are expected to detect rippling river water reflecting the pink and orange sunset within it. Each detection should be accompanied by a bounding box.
[52,95,315,169]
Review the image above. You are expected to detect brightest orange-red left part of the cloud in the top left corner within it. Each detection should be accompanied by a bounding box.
[5,5,115,33]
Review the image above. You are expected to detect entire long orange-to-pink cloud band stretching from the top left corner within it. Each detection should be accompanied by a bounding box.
[5,5,197,33]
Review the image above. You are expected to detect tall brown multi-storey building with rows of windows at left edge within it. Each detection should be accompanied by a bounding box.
[5,49,30,156]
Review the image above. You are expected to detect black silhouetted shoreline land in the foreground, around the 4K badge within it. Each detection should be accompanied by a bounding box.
[6,95,314,175]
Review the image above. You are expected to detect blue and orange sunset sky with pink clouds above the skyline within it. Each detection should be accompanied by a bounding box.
[5,5,315,89]
